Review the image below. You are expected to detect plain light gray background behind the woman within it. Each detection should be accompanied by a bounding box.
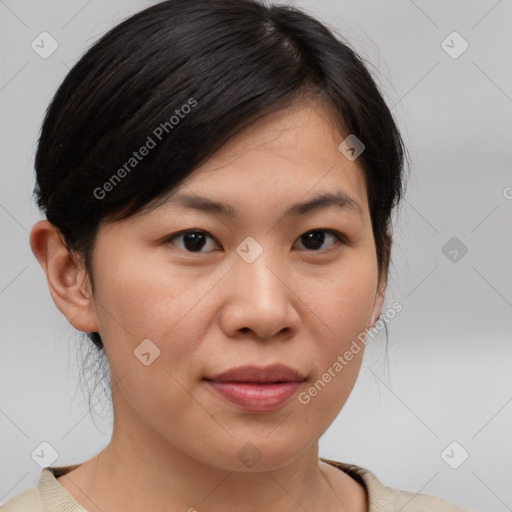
[0,0,512,512]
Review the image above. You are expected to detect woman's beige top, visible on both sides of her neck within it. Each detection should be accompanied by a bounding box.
[0,457,469,512]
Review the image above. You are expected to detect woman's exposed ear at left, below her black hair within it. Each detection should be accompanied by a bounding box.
[30,220,98,332]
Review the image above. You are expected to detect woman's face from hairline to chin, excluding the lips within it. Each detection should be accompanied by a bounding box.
[83,98,384,470]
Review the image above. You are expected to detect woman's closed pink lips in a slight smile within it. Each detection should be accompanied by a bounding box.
[206,364,305,412]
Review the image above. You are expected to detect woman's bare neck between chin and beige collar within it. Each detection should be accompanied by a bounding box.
[59,388,362,512]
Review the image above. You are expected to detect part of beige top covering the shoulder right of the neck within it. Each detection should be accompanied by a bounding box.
[321,458,469,512]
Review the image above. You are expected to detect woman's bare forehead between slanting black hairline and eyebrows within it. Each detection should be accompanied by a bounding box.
[164,100,366,213]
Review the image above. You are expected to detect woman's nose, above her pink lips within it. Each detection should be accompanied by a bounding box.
[220,251,301,339]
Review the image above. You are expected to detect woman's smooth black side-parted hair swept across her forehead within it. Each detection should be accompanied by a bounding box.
[34,0,407,410]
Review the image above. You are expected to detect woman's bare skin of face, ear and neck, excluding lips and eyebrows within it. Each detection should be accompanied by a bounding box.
[30,100,386,512]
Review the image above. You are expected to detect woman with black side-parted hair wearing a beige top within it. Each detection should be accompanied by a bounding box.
[2,0,463,512]
